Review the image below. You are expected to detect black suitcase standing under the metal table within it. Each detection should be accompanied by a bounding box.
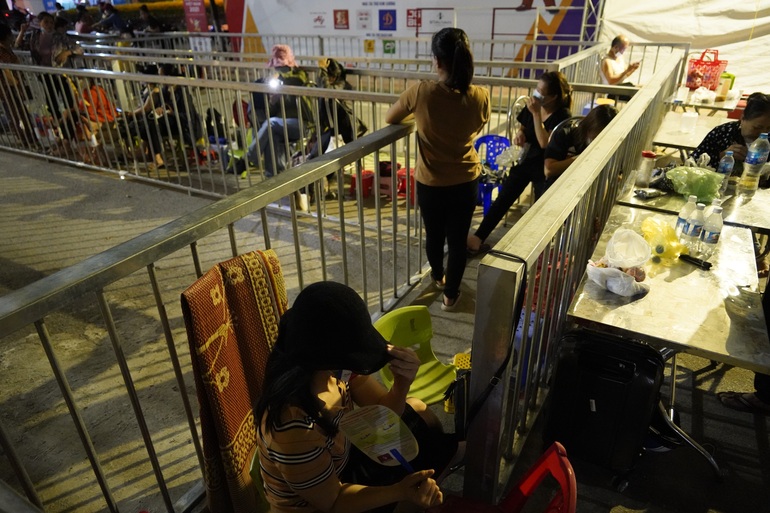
[544,329,664,474]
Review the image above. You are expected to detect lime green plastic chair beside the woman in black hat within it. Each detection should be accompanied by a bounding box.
[374,306,457,404]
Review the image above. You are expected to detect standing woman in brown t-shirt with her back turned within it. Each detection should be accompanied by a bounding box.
[385,28,490,311]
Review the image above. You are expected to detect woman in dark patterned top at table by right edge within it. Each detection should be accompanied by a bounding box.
[692,93,770,170]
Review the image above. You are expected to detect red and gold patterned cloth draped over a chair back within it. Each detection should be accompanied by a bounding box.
[182,250,288,513]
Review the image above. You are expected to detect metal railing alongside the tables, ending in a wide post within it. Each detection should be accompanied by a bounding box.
[464,51,682,501]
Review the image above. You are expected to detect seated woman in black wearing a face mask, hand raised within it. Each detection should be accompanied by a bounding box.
[466,71,572,256]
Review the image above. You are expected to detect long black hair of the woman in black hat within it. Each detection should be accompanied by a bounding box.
[254,316,338,436]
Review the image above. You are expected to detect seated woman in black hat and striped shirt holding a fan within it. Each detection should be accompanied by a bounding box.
[254,281,457,513]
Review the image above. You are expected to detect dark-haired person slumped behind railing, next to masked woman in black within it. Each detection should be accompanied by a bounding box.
[544,105,618,188]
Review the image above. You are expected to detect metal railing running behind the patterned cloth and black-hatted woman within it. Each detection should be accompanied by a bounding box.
[0,125,425,512]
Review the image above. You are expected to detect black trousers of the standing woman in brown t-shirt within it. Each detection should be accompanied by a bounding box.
[417,179,479,298]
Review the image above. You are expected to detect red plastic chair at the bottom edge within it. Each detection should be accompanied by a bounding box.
[427,442,577,513]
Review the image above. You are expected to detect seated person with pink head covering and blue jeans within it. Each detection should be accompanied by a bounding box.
[247,45,312,177]
